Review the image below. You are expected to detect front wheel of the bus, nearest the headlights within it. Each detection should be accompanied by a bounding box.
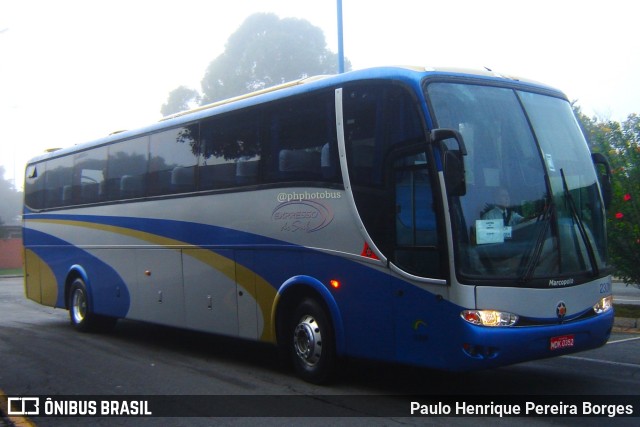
[289,298,336,384]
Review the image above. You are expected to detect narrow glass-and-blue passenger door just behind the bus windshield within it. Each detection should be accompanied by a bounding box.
[388,148,448,363]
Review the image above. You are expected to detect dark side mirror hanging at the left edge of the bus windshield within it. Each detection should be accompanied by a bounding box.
[430,129,467,196]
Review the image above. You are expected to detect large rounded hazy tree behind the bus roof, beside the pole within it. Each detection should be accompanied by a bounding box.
[202,13,351,104]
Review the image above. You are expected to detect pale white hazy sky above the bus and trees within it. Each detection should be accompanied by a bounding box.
[0,0,640,189]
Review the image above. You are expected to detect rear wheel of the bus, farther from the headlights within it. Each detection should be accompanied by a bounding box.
[69,277,117,332]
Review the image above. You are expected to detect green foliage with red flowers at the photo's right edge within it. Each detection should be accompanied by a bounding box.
[574,106,640,283]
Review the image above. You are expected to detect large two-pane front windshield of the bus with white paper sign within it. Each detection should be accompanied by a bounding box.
[426,82,606,287]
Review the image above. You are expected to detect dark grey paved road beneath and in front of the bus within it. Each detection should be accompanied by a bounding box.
[0,279,640,427]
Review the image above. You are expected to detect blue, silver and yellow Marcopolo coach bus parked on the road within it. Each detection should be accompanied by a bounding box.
[23,67,614,383]
